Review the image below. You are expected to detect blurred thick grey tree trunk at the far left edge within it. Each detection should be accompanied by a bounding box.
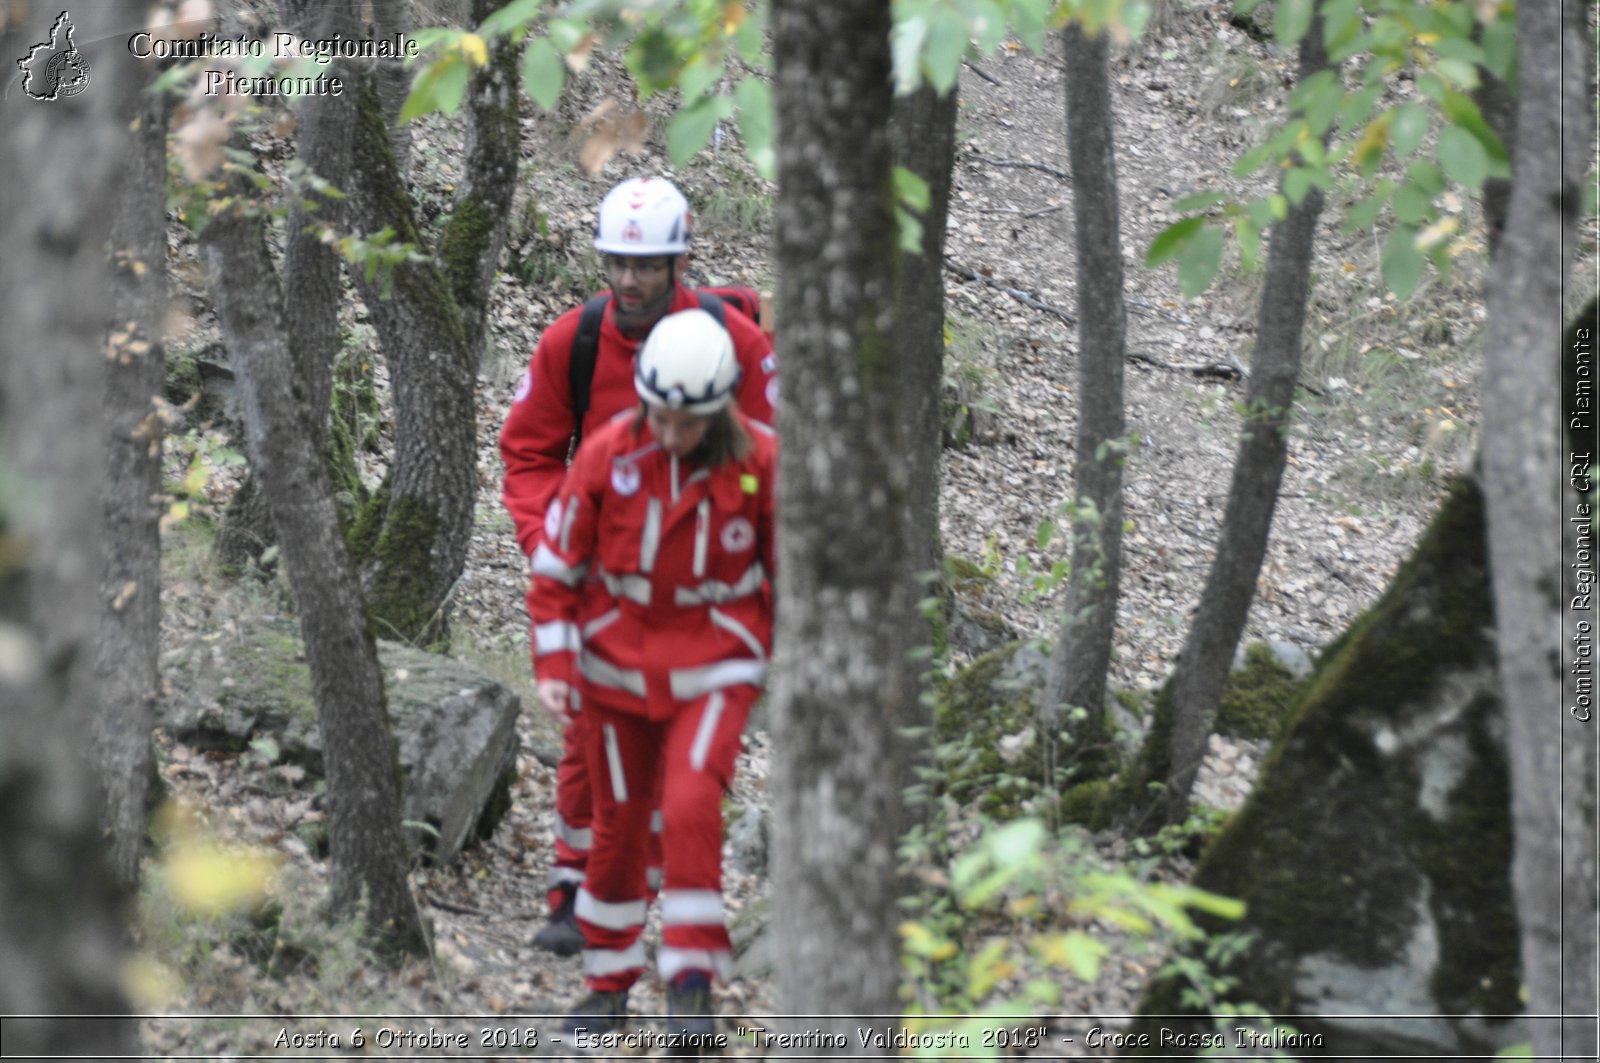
[0,5,138,1058]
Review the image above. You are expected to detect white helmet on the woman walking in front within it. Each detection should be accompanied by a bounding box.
[634,309,739,415]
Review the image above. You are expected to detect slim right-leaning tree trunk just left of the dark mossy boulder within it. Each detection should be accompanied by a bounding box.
[1166,14,1328,823]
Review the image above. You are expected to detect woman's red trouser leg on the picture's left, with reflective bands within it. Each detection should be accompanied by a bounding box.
[574,700,662,993]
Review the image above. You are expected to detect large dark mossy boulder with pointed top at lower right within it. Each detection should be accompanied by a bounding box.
[1134,483,1526,1058]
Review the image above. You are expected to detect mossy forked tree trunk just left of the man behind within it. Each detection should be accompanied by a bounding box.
[352,0,520,644]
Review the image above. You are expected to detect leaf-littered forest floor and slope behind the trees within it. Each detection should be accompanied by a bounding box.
[144,2,1594,1058]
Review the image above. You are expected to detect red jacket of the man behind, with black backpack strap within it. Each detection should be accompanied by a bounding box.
[501,285,778,557]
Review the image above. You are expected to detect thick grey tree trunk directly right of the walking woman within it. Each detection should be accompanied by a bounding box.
[773,0,915,1037]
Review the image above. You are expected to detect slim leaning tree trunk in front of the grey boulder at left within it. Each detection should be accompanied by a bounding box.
[202,184,424,951]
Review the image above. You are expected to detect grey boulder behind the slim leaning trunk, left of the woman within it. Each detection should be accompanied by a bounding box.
[160,616,520,863]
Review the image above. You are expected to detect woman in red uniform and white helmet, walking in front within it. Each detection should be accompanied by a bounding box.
[531,309,778,1034]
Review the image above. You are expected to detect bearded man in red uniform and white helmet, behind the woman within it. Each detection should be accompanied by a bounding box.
[499,178,778,956]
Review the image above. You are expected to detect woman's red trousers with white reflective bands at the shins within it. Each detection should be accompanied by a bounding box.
[576,685,760,991]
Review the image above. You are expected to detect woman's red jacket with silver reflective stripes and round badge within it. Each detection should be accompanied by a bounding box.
[530,413,778,719]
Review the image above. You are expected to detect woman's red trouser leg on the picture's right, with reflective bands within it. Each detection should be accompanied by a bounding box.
[656,685,758,978]
